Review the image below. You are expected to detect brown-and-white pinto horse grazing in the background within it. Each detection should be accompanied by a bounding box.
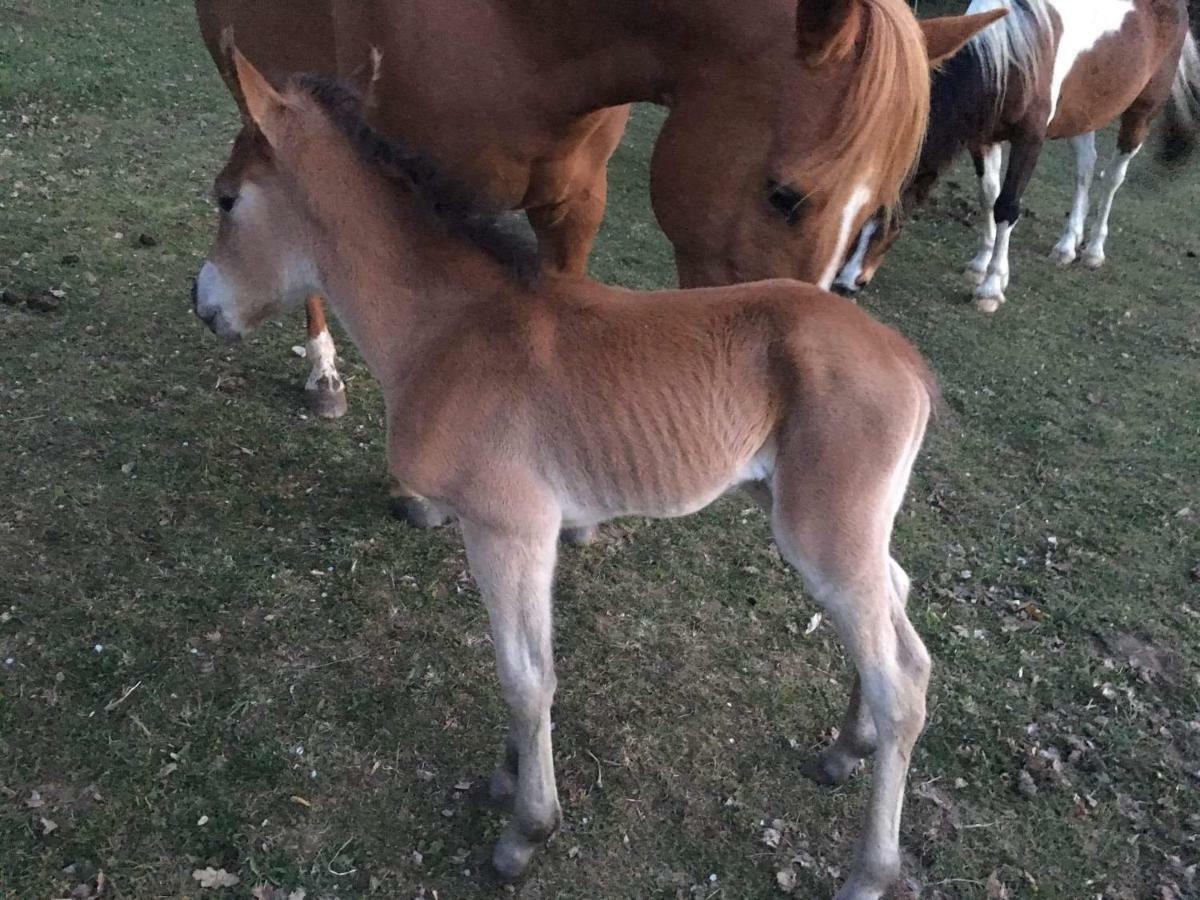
[838,0,1200,313]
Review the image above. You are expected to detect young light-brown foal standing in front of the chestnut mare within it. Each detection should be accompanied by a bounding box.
[194,52,937,900]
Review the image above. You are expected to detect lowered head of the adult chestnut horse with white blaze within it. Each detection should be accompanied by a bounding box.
[652,0,1003,287]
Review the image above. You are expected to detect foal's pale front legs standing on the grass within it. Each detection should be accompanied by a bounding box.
[463,511,562,878]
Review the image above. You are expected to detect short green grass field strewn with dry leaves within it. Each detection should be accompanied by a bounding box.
[0,0,1200,900]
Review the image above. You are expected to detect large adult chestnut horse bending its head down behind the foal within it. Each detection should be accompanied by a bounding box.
[196,0,994,414]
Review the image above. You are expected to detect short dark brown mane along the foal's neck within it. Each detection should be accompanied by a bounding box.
[295,74,541,287]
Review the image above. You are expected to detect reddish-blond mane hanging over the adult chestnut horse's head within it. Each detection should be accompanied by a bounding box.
[804,0,929,210]
